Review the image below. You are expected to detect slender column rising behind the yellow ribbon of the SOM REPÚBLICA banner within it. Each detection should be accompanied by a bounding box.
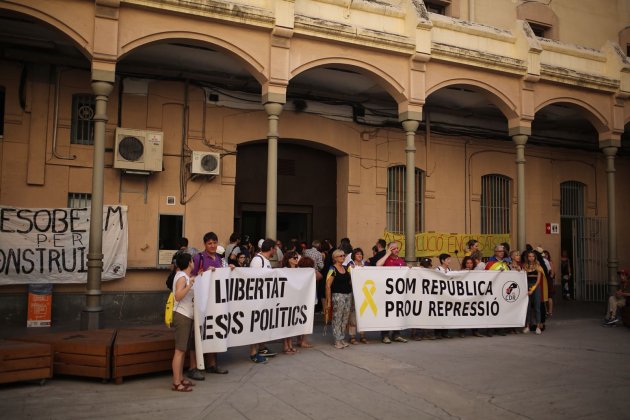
[402,120,420,263]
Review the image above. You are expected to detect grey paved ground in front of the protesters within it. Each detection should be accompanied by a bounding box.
[0,302,630,420]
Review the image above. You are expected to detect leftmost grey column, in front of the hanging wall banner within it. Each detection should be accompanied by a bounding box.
[81,80,114,330]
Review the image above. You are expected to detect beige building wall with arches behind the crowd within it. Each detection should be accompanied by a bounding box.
[0,0,630,296]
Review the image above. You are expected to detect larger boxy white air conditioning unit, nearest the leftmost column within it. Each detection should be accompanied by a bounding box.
[114,128,164,175]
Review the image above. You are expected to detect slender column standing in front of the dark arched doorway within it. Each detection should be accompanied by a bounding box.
[265,102,283,239]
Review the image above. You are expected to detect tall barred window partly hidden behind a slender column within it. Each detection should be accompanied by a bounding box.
[387,165,423,233]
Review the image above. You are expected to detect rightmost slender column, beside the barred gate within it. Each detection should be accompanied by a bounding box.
[602,146,619,295]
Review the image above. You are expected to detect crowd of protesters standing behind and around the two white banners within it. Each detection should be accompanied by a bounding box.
[172,232,592,392]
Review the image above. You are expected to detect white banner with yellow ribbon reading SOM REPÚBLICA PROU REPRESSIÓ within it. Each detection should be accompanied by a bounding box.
[351,267,528,331]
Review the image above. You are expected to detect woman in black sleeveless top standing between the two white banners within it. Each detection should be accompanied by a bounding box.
[324,249,352,349]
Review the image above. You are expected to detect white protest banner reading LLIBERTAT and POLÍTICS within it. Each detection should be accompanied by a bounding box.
[193,268,315,353]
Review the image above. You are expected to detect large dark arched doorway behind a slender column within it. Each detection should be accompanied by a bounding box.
[234,142,337,244]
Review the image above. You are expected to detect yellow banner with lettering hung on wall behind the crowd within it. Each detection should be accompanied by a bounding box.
[383,231,510,257]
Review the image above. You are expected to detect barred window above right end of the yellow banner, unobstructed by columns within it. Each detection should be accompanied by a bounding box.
[481,174,511,233]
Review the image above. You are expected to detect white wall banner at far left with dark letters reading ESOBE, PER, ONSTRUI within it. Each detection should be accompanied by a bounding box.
[0,206,127,285]
